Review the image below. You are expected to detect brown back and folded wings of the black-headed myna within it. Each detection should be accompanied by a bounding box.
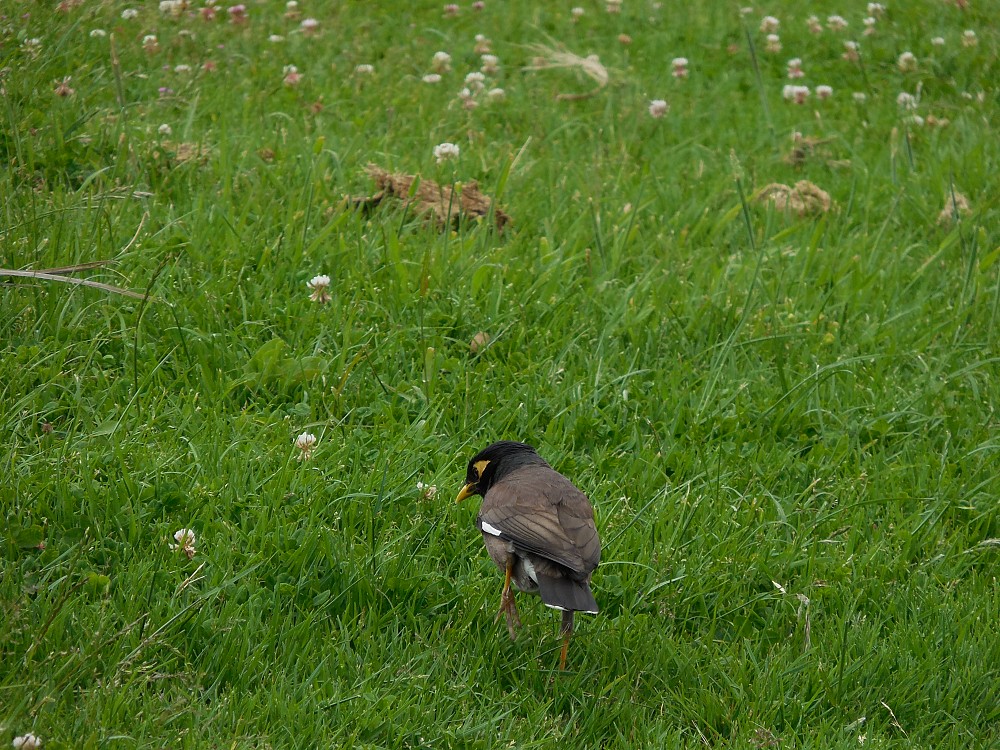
[477,466,601,577]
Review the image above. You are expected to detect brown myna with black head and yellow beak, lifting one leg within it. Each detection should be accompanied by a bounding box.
[457,440,601,669]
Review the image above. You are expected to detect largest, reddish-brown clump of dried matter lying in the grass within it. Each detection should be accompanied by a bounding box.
[348,164,510,231]
